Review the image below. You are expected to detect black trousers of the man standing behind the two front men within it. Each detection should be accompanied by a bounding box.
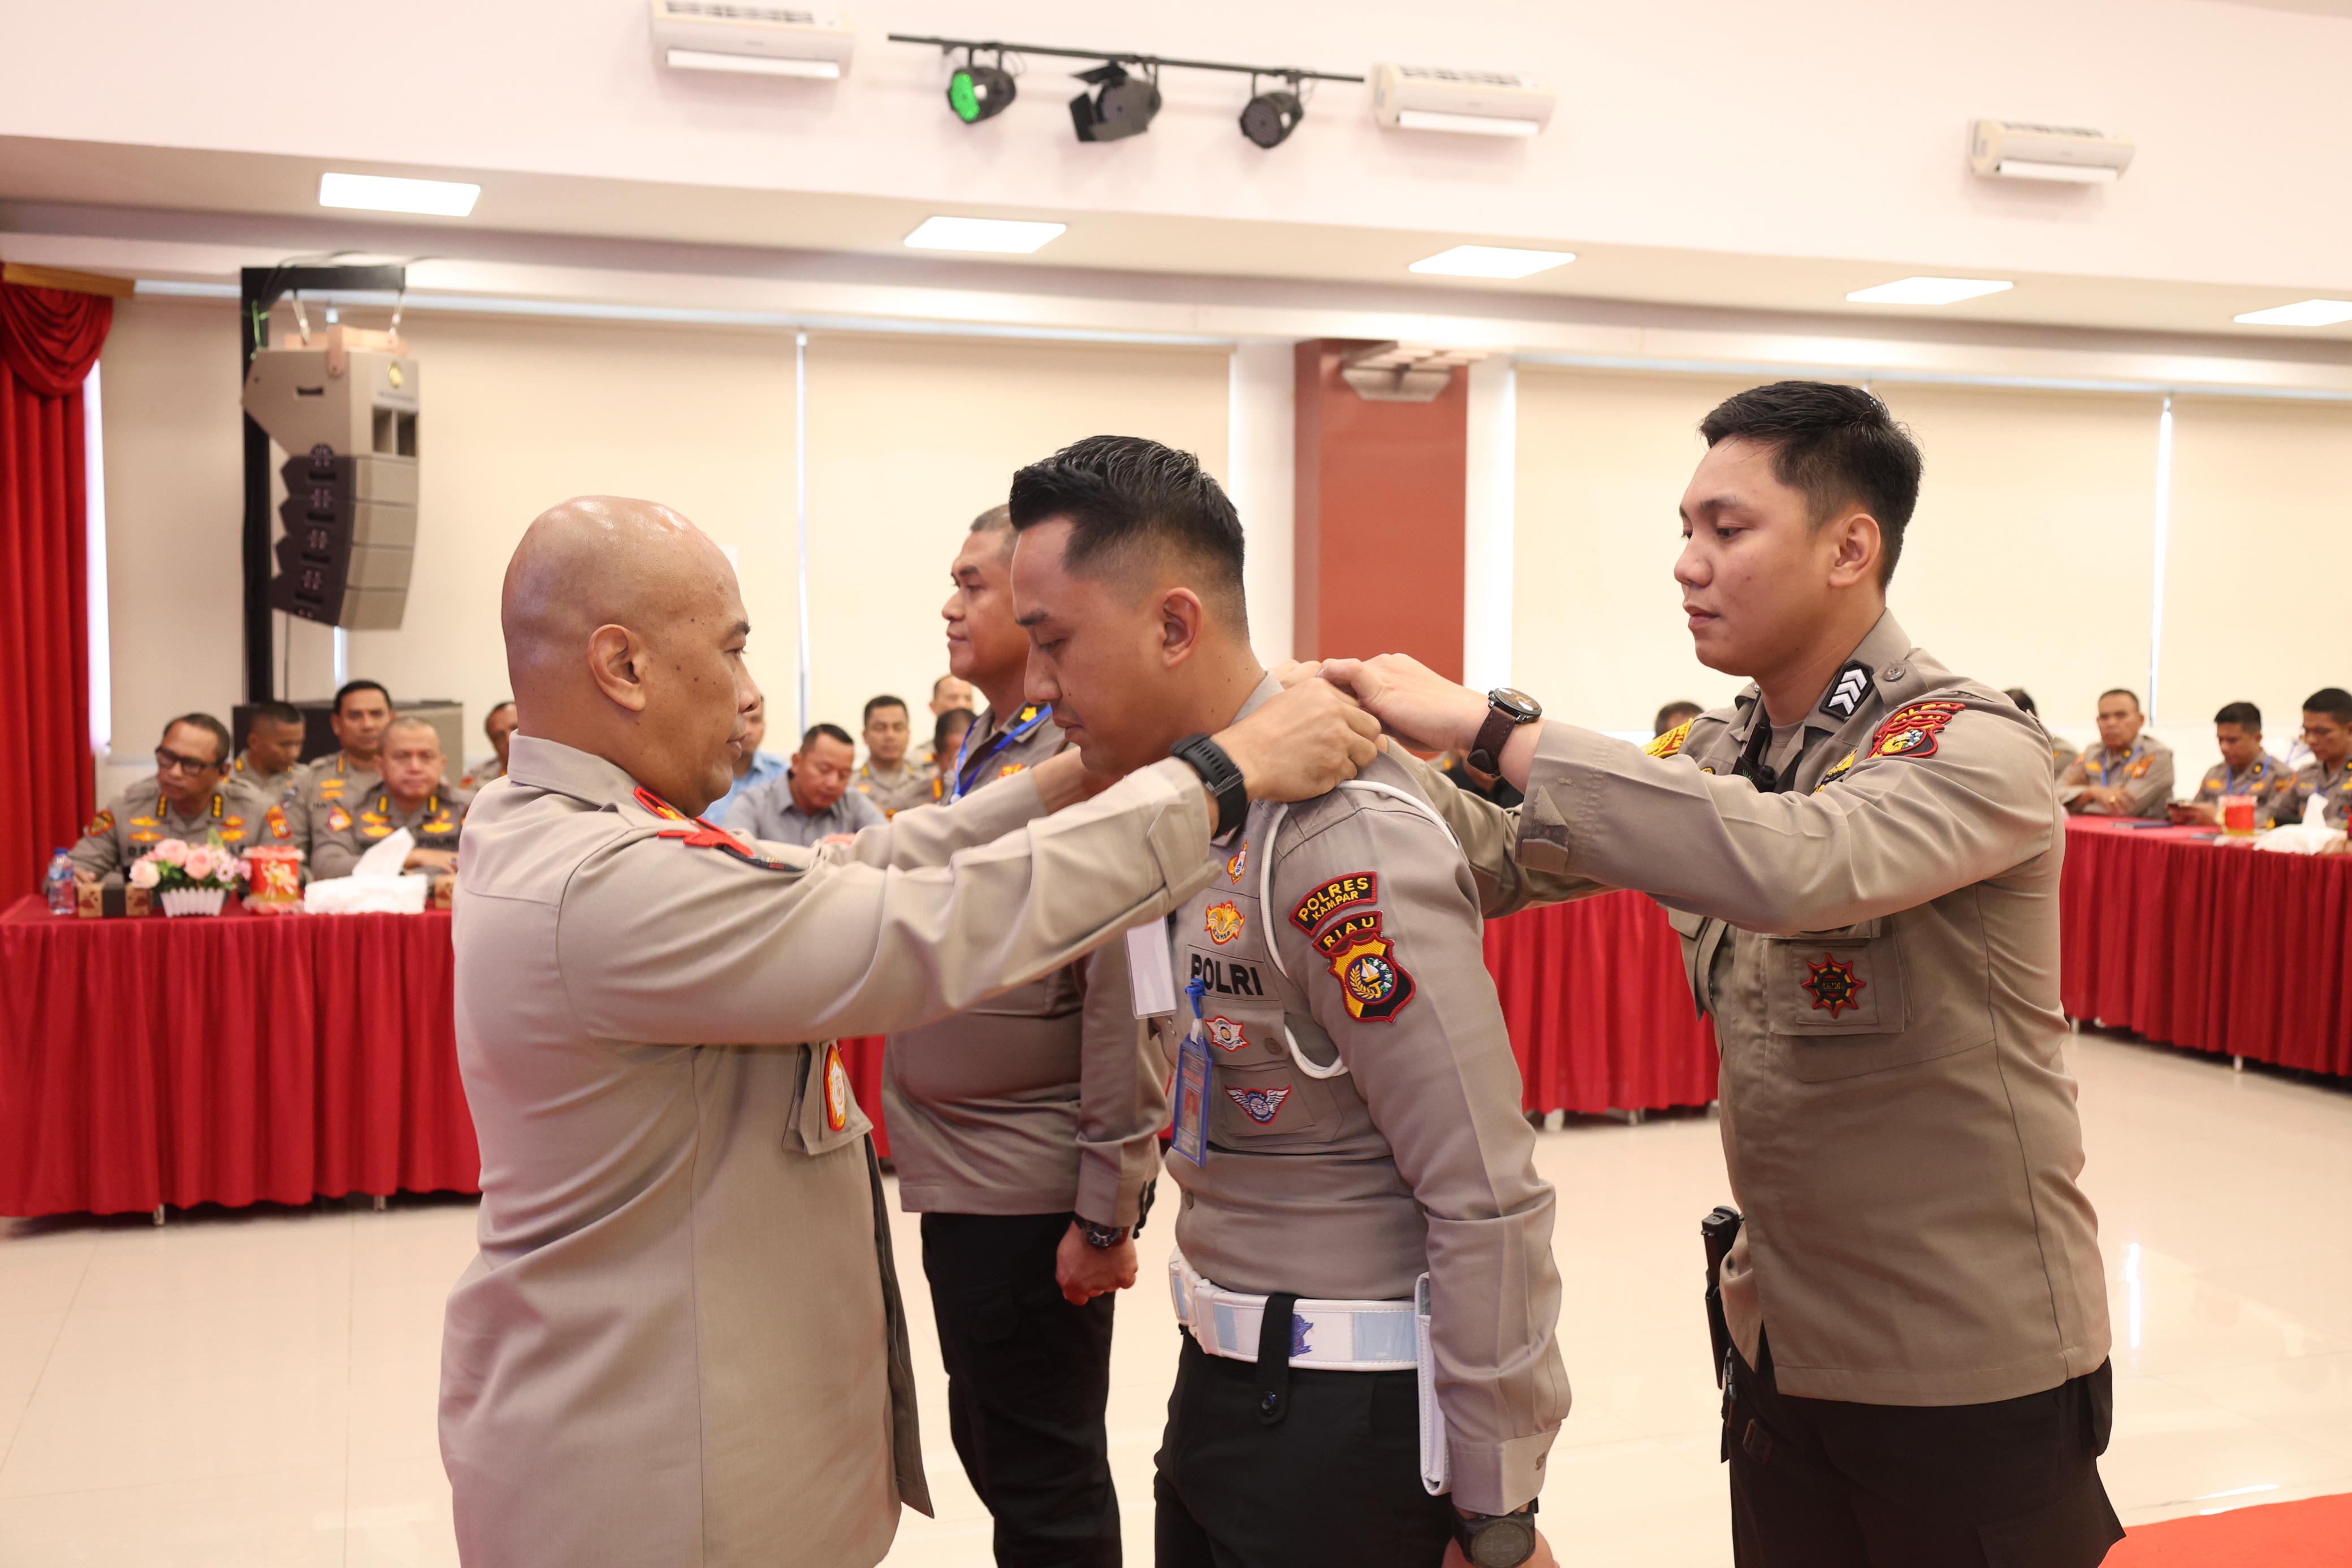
[922,1213,1119,1568]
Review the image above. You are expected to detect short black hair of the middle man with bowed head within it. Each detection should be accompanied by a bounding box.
[1006,435,1249,635]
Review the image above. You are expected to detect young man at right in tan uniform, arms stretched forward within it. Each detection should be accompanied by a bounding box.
[1324,383,2121,1568]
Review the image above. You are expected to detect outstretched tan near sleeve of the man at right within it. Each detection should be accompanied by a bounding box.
[1519,691,2056,933]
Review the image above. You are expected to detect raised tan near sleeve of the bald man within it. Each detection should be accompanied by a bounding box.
[555,761,1216,1046]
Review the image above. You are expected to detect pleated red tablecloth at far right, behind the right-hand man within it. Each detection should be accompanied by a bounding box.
[2058,818,2352,1075]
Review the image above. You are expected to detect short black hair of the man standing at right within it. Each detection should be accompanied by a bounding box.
[1698,381,1919,588]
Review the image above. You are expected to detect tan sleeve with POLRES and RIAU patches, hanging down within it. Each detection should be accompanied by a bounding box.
[1265,802,1569,1514]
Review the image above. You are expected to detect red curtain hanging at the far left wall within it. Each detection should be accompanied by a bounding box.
[0,282,115,896]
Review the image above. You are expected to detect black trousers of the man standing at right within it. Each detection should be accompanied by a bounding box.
[1724,1342,2124,1568]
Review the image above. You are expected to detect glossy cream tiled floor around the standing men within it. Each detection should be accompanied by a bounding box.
[0,1037,2352,1568]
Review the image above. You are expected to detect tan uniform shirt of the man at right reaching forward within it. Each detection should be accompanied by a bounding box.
[1416,616,2107,1406]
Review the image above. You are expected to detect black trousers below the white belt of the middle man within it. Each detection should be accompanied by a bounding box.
[1152,1326,1454,1568]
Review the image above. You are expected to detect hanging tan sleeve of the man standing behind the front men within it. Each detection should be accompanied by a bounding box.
[1077,930,1169,1225]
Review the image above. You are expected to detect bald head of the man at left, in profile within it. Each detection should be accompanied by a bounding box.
[499,496,758,811]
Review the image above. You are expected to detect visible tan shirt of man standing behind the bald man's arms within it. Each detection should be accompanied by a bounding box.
[882,708,1166,1225]
